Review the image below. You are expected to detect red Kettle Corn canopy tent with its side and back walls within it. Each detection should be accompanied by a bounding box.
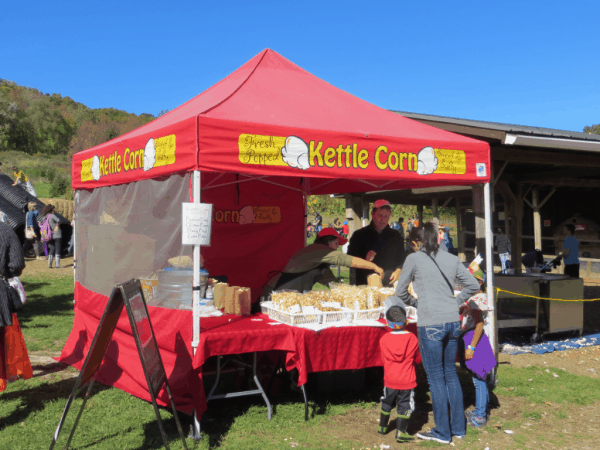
[61,49,490,420]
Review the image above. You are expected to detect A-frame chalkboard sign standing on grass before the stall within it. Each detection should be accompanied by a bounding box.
[50,280,188,450]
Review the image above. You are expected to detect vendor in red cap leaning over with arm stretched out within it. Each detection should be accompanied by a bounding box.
[261,228,383,301]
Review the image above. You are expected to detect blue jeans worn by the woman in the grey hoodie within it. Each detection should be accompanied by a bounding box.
[418,322,466,440]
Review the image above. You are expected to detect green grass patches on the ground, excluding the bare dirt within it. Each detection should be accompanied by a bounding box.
[9,270,600,450]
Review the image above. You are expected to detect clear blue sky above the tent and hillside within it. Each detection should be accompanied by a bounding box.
[0,0,600,131]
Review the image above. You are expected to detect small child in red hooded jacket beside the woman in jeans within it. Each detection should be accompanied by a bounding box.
[377,299,419,442]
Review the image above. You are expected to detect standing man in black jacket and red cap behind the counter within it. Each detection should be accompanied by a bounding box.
[348,200,406,286]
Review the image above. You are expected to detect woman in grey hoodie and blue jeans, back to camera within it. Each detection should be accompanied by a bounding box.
[396,223,479,444]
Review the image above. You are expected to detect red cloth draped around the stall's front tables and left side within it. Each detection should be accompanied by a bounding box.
[57,283,416,416]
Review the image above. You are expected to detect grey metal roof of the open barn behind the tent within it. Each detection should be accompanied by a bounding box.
[390,110,600,142]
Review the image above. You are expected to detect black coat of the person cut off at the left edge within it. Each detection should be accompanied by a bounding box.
[0,222,25,327]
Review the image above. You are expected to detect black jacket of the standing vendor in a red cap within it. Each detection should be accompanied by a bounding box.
[348,222,406,286]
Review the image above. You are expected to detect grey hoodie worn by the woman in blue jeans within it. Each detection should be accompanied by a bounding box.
[396,249,480,327]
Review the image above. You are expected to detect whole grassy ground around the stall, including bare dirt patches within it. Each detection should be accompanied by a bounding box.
[0,264,600,450]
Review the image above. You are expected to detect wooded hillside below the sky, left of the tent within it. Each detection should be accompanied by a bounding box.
[0,79,155,156]
